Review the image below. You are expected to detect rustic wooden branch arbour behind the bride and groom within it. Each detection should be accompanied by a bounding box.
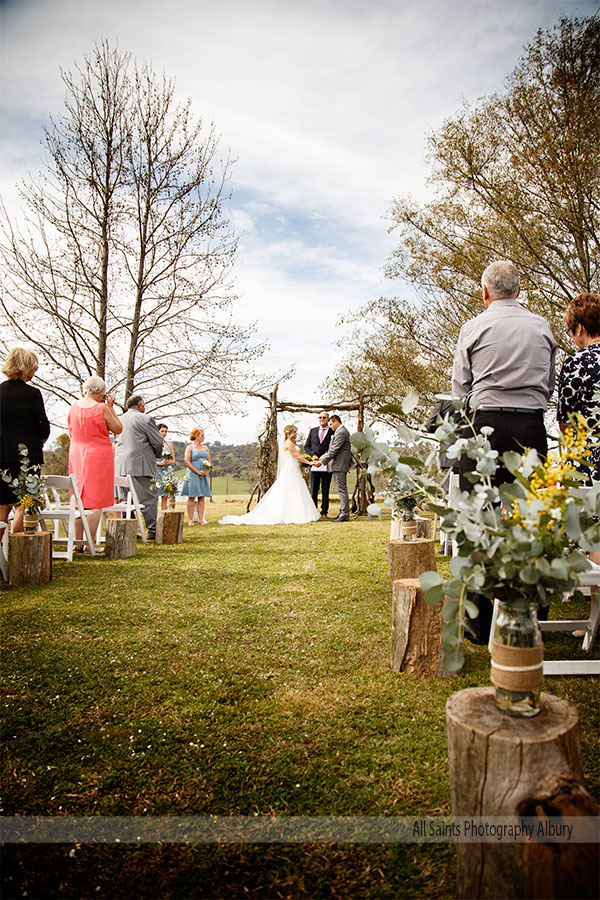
[246,384,373,515]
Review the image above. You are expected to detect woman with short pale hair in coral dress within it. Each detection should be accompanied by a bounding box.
[68,375,123,540]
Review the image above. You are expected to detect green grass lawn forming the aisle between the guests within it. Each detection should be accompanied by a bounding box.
[0,498,600,898]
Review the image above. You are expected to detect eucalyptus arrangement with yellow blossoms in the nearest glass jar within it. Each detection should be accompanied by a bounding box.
[352,401,600,670]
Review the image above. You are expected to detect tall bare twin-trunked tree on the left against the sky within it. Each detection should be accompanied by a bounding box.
[0,42,260,415]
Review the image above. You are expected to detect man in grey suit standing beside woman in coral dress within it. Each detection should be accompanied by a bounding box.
[115,394,163,541]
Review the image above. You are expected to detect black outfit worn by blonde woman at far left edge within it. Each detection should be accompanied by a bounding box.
[0,378,50,504]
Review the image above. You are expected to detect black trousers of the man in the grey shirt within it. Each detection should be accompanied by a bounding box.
[459,408,548,644]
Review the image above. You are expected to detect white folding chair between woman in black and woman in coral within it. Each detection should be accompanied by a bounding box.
[39,475,96,562]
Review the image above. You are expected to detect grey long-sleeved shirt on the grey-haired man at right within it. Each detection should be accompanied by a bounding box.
[452,299,556,409]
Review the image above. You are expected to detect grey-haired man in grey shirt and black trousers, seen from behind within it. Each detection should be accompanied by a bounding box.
[452,260,556,490]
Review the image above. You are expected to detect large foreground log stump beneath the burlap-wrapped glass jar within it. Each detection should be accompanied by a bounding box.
[446,687,598,898]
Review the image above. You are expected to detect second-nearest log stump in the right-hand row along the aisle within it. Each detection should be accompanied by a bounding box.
[390,578,449,678]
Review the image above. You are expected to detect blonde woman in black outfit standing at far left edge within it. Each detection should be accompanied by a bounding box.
[0,347,50,532]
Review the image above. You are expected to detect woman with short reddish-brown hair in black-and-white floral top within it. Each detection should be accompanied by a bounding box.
[556,294,600,480]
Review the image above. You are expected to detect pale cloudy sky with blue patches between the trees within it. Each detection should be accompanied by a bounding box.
[0,0,599,443]
